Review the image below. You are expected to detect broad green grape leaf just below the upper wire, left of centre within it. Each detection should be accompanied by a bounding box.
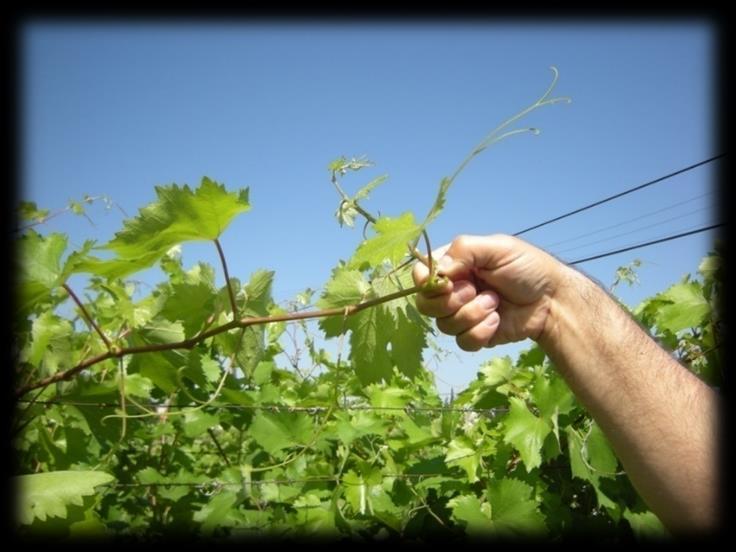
[248,412,314,454]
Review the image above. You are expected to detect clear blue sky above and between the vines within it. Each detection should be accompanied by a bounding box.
[20,20,721,391]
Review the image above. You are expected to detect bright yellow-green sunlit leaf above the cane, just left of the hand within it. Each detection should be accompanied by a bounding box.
[348,211,422,268]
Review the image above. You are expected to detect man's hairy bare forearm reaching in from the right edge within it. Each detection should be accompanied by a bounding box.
[539,268,718,532]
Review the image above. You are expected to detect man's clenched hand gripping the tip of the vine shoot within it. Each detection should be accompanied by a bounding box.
[413,234,565,351]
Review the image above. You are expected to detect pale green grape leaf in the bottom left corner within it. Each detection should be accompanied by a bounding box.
[13,471,115,525]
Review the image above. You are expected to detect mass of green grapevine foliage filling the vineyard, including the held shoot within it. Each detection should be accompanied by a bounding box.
[13,69,722,540]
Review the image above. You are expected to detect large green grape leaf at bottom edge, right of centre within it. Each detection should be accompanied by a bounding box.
[488,477,546,535]
